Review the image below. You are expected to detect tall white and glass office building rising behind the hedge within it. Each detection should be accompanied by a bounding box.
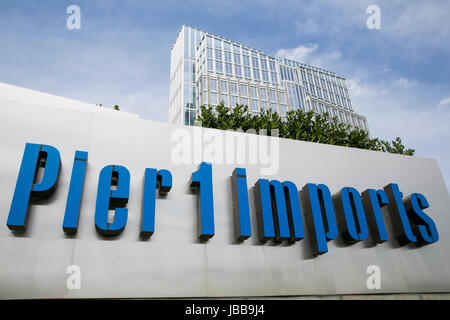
[169,26,368,131]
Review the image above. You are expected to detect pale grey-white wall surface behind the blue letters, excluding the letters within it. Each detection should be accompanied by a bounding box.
[0,86,450,298]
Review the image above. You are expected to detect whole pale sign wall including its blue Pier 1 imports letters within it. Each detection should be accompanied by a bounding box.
[0,101,450,298]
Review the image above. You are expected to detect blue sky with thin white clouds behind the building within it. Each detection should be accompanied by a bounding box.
[0,0,450,189]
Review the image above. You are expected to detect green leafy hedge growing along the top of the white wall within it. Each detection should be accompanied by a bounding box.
[197,103,415,156]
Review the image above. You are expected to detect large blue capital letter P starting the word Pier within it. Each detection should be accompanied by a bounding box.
[6,143,61,231]
